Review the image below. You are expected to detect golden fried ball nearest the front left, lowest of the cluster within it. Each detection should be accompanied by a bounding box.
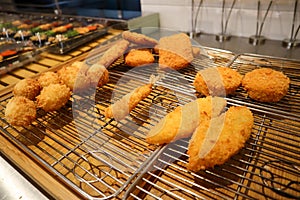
[5,96,36,126]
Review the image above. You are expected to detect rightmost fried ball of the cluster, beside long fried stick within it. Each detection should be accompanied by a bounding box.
[87,64,109,87]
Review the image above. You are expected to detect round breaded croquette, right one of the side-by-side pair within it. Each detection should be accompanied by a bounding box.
[242,68,290,102]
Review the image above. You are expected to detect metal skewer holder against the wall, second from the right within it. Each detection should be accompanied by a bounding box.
[249,1,273,46]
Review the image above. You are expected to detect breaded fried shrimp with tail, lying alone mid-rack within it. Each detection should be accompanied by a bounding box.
[104,75,156,121]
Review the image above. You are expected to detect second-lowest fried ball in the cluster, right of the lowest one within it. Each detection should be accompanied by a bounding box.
[36,84,71,112]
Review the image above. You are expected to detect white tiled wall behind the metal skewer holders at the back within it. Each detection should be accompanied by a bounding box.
[141,0,300,40]
